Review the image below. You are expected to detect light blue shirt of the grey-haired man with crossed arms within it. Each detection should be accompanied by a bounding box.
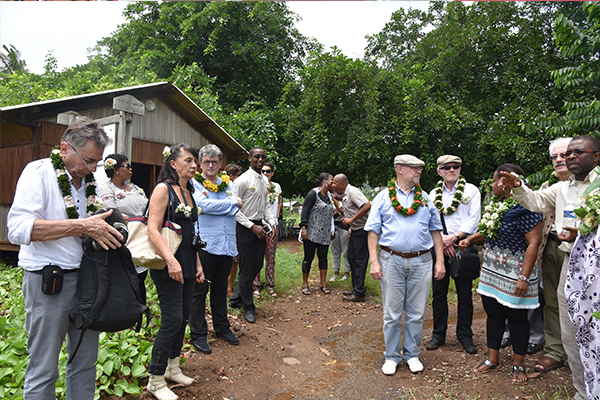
[191,177,240,257]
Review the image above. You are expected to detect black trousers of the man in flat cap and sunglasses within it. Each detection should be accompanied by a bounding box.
[431,256,473,343]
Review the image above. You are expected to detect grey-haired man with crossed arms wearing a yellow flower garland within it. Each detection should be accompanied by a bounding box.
[190,144,242,354]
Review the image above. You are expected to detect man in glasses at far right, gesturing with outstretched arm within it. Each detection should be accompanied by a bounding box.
[500,136,600,399]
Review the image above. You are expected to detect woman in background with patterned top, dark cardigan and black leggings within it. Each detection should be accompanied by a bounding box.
[300,172,335,295]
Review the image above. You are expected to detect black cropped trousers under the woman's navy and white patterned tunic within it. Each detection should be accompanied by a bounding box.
[481,296,529,356]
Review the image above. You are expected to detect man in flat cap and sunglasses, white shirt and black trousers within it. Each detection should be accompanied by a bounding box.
[426,155,481,354]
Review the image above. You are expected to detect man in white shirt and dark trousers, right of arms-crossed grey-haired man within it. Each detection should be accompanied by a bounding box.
[229,147,275,324]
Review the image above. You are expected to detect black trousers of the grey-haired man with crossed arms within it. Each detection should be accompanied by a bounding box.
[190,250,233,340]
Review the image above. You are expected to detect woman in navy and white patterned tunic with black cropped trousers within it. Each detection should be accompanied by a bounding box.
[458,164,542,384]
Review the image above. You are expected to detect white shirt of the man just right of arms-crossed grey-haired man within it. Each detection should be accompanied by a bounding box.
[234,168,275,229]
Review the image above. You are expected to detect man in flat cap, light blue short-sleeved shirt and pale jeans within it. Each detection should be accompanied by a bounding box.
[365,154,446,375]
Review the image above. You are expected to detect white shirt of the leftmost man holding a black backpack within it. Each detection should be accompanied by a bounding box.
[7,158,87,271]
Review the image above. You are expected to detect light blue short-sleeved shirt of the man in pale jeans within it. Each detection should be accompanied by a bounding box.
[365,185,442,253]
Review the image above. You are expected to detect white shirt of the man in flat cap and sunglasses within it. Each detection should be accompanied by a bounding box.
[429,181,481,235]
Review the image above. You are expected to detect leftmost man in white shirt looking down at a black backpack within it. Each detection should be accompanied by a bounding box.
[7,117,123,400]
